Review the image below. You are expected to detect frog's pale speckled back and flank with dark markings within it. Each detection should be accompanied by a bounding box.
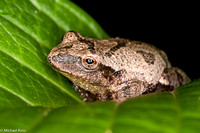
[97,38,170,85]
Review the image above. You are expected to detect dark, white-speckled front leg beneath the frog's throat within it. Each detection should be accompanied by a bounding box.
[73,85,97,102]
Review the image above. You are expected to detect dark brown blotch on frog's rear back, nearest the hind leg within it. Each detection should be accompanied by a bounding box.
[137,50,155,65]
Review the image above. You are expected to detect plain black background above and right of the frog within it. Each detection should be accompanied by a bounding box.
[72,0,200,80]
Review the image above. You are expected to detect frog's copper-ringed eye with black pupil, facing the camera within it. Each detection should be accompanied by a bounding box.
[82,56,98,69]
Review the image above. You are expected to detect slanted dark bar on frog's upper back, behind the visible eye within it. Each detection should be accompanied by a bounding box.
[105,40,127,57]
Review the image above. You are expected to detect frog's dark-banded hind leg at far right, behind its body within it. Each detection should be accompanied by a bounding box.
[156,67,190,91]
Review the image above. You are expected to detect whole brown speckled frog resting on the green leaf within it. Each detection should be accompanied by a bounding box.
[48,31,190,102]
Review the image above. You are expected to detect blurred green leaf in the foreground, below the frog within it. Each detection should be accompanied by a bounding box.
[0,80,200,133]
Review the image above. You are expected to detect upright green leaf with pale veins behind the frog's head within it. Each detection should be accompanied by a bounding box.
[0,0,107,108]
